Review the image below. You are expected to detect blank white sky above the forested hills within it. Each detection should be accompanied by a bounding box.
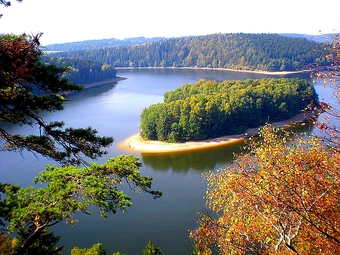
[0,0,340,45]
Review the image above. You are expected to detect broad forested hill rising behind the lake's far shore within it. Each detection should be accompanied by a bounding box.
[48,33,325,71]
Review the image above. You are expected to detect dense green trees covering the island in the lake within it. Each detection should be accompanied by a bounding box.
[140,78,318,142]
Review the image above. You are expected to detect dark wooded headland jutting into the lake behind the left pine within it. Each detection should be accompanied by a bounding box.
[41,55,117,84]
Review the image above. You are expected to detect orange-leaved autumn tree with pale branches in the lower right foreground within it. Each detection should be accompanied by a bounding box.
[191,126,340,254]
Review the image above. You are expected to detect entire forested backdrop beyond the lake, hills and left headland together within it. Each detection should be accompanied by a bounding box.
[42,33,332,84]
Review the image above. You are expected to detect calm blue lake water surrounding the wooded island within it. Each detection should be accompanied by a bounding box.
[0,69,327,255]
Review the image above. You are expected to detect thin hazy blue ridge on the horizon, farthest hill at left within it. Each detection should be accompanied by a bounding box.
[43,37,164,51]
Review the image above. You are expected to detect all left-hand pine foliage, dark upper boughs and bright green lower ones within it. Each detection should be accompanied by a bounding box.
[0,35,161,254]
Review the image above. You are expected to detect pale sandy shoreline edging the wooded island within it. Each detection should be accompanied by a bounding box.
[118,114,311,153]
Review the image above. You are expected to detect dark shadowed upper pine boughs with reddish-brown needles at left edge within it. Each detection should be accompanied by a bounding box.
[0,34,113,164]
